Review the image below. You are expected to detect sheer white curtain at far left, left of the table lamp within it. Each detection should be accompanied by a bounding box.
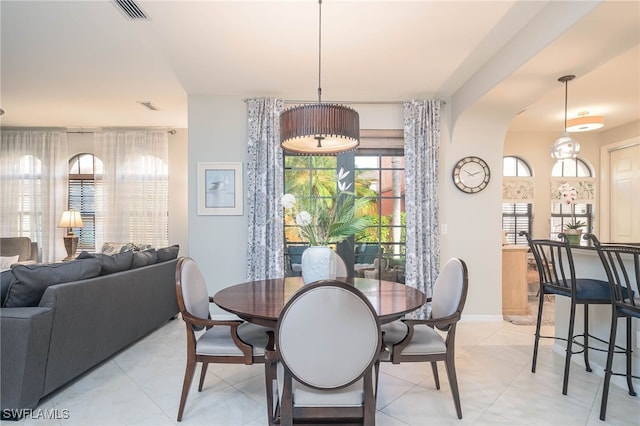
[0,130,69,262]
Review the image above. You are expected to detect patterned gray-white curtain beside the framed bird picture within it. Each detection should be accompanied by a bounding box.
[247,98,284,281]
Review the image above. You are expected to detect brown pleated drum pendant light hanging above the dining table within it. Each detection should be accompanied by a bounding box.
[280,0,360,155]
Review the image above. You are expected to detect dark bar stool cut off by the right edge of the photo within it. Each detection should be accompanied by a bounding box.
[584,234,640,420]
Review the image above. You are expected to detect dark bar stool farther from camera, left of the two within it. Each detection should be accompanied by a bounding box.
[520,231,611,395]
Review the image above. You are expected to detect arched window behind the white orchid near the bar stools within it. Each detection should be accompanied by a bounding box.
[551,158,593,239]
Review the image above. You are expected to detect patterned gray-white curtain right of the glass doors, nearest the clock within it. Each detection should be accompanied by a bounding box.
[404,100,440,319]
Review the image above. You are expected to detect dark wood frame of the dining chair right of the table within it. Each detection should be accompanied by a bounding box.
[376,259,469,419]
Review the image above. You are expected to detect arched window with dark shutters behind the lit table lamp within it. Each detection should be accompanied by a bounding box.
[69,154,102,251]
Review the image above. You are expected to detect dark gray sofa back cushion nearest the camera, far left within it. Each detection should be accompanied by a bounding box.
[4,259,102,308]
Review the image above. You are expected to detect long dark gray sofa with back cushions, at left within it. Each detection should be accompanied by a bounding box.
[0,246,178,418]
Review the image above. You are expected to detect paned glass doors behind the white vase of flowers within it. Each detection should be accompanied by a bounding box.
[284,147,405,281]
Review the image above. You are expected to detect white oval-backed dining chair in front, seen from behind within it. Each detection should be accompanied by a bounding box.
[267,280,381,425]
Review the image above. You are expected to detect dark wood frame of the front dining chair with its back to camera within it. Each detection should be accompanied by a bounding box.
[265,280,382,426]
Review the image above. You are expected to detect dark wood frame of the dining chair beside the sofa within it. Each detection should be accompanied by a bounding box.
[176,257,273,421]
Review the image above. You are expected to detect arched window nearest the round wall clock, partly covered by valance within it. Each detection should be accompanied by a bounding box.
[502,156,533,244]
